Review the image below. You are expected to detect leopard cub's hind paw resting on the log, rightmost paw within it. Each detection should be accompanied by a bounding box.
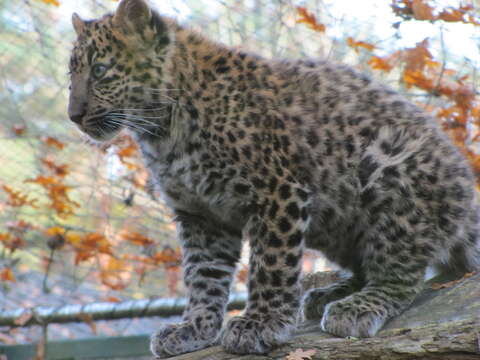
[320,296,387,338]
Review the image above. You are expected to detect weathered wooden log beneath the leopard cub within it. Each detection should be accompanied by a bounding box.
[170,273,480,360]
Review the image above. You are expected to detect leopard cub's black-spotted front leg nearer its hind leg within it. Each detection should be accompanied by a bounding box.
[222,183,308,354]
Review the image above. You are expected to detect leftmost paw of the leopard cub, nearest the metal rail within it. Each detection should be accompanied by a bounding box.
[150,322,218,359]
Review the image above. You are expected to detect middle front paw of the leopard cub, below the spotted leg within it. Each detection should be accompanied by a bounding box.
[221,315,295,354]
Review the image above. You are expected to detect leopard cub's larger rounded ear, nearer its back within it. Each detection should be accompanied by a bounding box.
[113,0,152,35]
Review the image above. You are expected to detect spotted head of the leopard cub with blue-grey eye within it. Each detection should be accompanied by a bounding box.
[68,0,173,141]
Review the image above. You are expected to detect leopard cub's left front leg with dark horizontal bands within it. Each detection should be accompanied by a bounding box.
[150,213,241,359]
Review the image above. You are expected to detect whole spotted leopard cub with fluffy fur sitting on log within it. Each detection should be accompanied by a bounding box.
[68,0,480,358]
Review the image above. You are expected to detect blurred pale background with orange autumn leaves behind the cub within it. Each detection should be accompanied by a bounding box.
[0,0,480,350]
